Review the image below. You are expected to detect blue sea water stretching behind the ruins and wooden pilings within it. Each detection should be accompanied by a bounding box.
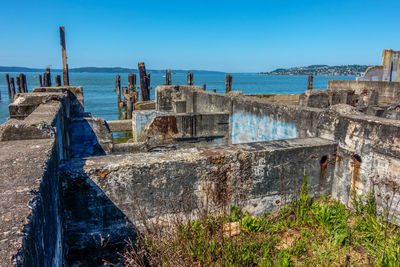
[0,72,355,124]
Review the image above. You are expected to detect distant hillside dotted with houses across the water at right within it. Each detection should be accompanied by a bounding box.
[259,65,369,76]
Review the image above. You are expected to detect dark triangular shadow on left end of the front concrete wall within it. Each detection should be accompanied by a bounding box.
[61,163,136,266]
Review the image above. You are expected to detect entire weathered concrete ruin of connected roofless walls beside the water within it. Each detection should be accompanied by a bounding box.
[0,66,400,266]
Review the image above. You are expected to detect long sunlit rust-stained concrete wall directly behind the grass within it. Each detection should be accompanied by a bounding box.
[63,138,336,222]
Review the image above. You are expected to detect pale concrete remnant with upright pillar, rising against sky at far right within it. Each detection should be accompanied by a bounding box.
[357,49,400,82]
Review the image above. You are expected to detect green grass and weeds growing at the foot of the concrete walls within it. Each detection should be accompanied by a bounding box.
[124,177,400,266]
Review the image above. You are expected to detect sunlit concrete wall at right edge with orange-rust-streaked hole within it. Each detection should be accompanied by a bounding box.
[318,108,400,212]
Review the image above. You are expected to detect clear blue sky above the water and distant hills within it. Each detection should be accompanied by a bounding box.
[0,0,400,72]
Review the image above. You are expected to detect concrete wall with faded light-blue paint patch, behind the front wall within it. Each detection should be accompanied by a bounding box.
[156,86,321,143]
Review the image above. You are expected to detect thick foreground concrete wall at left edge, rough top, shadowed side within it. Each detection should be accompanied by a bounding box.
[0,139,63,267]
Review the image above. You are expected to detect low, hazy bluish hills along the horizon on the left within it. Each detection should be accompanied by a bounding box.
[0,66,224,74]
